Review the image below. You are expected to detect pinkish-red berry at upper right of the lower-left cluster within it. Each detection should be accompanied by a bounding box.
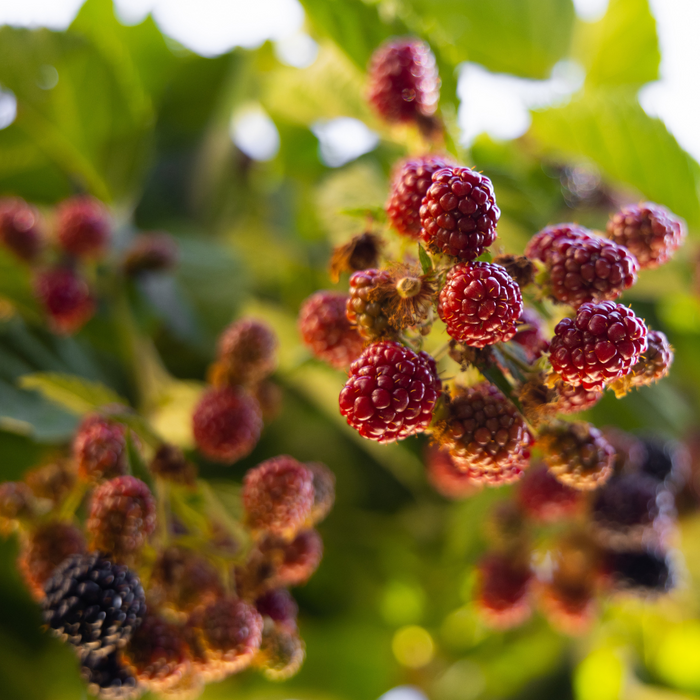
[242,455,314,535]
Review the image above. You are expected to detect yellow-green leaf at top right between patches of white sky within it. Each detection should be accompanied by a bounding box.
[575,0,661,87]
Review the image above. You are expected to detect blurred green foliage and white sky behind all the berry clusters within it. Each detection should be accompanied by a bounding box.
[0,0,700,700]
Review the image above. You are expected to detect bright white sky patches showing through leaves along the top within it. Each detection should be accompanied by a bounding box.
[0,0,700,166]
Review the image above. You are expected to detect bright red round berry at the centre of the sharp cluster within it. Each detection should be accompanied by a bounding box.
[438,262,523,348]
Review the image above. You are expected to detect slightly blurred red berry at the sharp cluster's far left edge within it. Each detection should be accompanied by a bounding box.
[299,292,364,369]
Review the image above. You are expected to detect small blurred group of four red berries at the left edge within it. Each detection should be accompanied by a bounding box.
[0,195,177,335]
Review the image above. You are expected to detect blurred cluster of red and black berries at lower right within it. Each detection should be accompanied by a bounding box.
[474,430,689,634]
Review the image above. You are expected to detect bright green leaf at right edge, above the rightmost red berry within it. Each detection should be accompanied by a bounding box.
[529,90,700,227]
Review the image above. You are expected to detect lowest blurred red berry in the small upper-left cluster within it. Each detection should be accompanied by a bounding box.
[34,267,95,335]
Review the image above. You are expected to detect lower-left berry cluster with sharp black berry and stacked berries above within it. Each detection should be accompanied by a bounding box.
[0,319,335,700]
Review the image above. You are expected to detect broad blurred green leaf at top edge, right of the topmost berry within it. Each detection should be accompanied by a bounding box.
[402,0,575,79]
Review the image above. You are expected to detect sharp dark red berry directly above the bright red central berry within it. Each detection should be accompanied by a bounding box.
[420,166,501,260]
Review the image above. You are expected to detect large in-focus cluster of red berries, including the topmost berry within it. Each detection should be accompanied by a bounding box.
[299,39,685,498]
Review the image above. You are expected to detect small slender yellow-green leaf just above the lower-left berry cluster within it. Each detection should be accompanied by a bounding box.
[19,372,126,414]
